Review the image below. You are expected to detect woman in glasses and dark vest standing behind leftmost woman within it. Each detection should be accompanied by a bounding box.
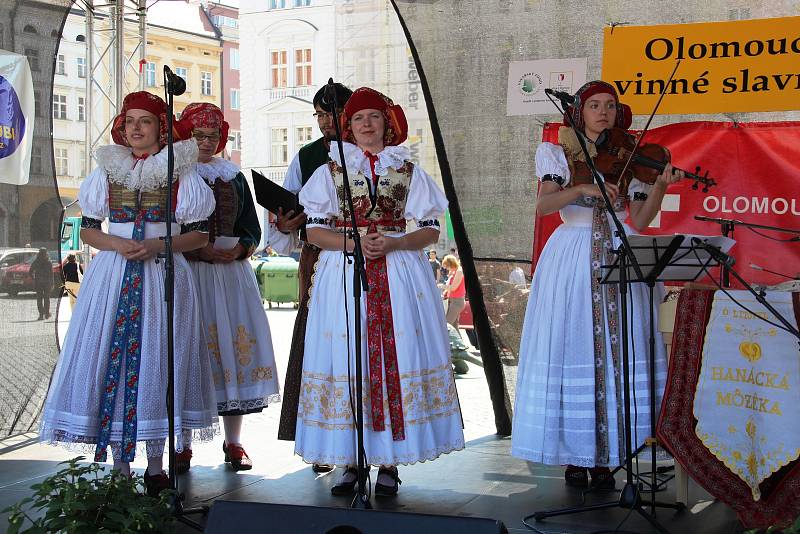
[176,103,279,472]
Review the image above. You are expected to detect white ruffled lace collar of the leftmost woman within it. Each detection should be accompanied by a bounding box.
[95,139,197,191]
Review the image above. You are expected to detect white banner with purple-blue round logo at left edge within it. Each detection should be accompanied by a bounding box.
[0,50,34,185]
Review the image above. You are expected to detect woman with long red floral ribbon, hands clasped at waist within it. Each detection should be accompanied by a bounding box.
[295,87,464,495]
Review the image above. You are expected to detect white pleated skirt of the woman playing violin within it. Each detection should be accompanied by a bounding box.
[511,206,667,467]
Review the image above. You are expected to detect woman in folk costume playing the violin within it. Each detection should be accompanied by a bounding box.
[511,81,681,489]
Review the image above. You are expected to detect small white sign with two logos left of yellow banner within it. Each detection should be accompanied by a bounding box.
[506,57,588,116]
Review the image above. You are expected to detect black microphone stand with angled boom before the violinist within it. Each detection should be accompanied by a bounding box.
[523,95,681,533]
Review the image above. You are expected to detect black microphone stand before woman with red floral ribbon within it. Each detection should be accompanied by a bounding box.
[325,78,372,510]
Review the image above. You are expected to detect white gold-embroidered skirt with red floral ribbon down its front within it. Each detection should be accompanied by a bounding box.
[295,245,464,465]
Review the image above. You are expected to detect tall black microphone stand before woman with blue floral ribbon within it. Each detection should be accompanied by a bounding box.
[162,65,208,532]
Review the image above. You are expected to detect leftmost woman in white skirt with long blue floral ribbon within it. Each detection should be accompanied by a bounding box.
[40,91,216,494]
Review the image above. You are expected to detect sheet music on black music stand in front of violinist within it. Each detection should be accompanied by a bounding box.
[603,234,736,282]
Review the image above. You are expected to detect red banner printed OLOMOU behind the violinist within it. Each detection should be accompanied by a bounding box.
[531,122,800,286]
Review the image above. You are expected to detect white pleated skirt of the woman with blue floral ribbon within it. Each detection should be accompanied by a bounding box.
[40,223,217,452]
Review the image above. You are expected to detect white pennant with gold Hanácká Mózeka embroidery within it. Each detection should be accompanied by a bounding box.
[694,291,800,500]
